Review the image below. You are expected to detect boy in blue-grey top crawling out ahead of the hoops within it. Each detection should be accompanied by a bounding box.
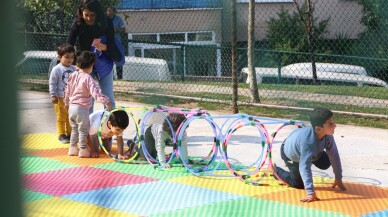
[274,108,346,202]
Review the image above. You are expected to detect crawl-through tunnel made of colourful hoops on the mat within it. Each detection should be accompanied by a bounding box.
[97,105,305,186]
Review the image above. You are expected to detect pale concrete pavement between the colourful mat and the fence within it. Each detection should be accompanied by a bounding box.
[19,91,388,187]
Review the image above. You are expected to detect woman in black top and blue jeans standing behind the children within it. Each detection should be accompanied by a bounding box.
[67,0,124,112]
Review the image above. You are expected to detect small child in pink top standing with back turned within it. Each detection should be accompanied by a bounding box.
[65,51,112,158]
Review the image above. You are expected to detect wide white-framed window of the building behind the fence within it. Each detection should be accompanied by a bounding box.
[128,31,221,76]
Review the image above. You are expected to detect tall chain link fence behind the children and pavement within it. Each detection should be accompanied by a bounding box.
[17,0,388,115]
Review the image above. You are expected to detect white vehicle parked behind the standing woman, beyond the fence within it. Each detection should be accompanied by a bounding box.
[16,51,171,81]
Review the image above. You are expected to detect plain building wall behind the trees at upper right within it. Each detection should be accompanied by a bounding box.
[237,0,365,41]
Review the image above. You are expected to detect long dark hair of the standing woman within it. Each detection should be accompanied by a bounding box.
[76,0,107,33]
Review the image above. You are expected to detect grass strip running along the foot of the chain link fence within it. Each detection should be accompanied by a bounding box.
[20,80,388,129]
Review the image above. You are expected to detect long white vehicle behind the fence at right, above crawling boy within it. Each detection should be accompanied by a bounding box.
[241,63,388,88]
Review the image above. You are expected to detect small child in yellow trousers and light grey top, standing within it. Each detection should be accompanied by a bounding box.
[49,43,75,143]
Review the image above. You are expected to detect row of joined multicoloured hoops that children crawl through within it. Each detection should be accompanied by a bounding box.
[98,105,304,185]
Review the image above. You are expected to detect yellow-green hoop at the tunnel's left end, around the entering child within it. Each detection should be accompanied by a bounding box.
[97,106,151,163]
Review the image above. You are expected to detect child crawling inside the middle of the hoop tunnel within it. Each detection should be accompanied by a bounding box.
[137,113,188,168]
